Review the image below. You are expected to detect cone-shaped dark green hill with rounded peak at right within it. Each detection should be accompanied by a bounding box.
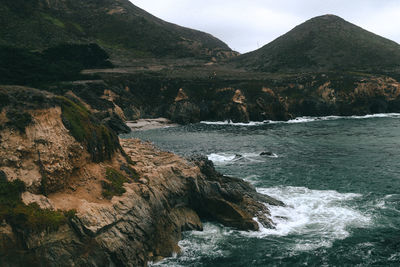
[234,15,400,72]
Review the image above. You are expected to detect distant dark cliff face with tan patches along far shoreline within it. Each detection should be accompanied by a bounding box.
[144,73,400,123]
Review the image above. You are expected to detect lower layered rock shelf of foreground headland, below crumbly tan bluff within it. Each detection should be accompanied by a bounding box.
[2,140,283,266]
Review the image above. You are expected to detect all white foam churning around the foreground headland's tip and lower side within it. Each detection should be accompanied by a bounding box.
[150,187,372,267]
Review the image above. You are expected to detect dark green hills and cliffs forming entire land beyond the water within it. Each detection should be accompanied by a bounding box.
[0,4,400,124]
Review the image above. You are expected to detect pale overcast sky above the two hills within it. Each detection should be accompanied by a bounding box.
[130,0,400,53]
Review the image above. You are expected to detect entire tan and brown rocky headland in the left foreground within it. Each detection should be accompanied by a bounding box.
[0,88,283,266]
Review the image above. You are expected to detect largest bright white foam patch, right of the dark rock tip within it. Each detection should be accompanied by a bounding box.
[245,187,372,250]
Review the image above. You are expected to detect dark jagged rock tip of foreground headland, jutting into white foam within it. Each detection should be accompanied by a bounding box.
[189,156,284,230]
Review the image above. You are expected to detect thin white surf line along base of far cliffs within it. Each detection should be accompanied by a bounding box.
[200,113,400,126]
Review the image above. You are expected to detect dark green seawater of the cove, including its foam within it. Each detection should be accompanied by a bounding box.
[120,114,400,266]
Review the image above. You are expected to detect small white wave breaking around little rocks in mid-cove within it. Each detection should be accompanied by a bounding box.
[207,152,279,164]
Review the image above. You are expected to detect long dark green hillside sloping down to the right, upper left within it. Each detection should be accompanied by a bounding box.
[0,0,235,59]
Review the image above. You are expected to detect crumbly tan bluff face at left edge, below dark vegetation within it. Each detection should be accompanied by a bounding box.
[0,107,89,193]
